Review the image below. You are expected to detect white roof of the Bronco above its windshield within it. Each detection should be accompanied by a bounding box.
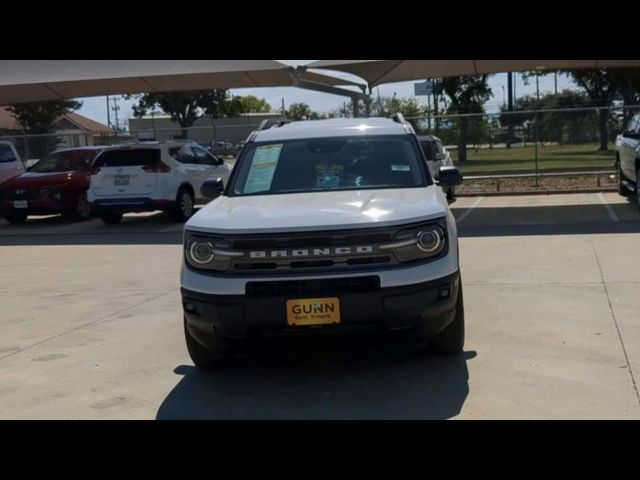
[254,118,407,142]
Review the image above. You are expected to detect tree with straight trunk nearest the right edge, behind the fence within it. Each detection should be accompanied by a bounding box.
[569,69,618,151]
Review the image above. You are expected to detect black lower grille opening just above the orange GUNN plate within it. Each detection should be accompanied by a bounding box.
[245,276,380,298]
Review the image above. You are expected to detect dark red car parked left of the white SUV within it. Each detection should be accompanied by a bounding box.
[0,147,105,223]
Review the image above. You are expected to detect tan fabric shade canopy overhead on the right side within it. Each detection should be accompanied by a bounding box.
[306,60,640,87]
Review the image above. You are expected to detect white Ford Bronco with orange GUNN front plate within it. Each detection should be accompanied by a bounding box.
[181,115,464,368]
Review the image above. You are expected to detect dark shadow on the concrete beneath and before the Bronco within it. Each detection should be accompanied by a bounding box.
[156,340,476,420]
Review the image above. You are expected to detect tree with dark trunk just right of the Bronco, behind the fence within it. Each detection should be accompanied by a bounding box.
[442,75,491,162]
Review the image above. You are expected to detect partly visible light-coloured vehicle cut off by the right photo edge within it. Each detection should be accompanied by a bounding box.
[616,112,640,207]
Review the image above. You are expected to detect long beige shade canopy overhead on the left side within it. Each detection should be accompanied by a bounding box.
[0,60,357,105]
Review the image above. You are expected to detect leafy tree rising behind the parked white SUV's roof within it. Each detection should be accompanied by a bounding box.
[126,88,235,138]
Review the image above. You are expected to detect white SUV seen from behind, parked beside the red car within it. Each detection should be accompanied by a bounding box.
[88,141,231,224]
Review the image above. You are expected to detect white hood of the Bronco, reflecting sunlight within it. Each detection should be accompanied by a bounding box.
[185,185,448,233]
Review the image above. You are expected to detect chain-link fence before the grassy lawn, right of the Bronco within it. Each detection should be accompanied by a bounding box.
[407,106,640,175]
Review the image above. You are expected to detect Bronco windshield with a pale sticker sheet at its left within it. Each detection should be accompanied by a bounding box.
[229,135,428,195]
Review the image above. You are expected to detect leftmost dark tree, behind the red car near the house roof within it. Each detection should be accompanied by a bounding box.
[7,100,82,158]
